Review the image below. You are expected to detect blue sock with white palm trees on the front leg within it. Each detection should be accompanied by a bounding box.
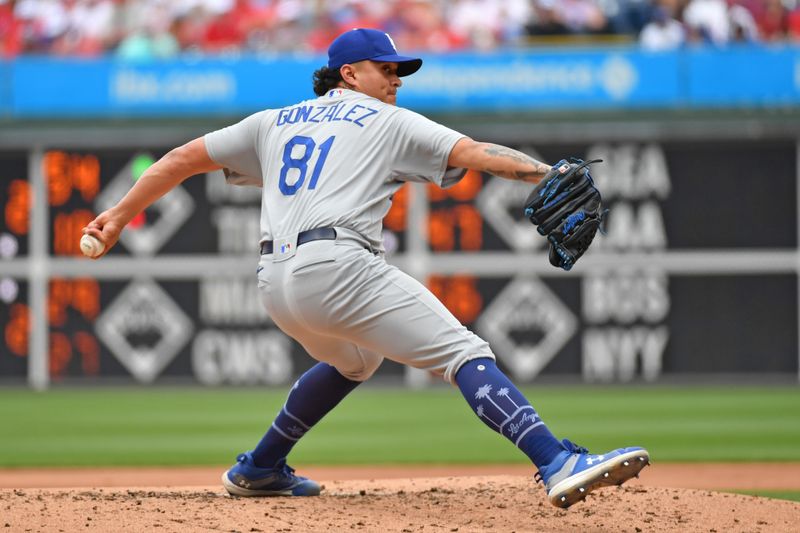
[456,359,565,468]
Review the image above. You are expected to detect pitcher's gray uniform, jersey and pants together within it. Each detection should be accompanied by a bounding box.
[205,89,494,381]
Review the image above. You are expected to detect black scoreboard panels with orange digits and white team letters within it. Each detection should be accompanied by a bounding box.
[0,140,798,384]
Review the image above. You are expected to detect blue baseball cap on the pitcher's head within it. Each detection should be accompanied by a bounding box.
[328,28,422,76]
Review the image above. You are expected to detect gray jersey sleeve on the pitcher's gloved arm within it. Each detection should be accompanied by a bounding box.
[391,109,466,187]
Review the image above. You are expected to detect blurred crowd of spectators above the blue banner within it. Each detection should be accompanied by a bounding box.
[0,0,800,59]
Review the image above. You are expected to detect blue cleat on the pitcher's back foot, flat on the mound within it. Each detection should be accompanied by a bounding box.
[222,452,321,496]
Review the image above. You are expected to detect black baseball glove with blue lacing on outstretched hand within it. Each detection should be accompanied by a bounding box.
[525,158,608,270]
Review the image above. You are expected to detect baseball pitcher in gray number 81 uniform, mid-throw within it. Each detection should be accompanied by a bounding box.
[83,29,650,507]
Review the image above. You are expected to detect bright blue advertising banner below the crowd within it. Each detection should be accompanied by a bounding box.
[6,45,800,118]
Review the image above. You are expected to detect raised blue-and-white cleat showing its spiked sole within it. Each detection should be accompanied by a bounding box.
[534,439,650,509]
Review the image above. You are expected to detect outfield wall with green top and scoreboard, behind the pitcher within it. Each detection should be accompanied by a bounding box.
[0,44,800,388]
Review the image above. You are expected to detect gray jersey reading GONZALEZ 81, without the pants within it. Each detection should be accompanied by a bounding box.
[205,89,463,250]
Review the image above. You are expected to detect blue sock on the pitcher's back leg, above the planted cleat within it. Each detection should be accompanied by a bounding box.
[253,363,361,468]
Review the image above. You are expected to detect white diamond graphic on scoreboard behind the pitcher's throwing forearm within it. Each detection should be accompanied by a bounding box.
[95,152,194,255]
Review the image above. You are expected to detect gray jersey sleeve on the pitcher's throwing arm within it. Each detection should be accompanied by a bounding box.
[204,111,267,186]
